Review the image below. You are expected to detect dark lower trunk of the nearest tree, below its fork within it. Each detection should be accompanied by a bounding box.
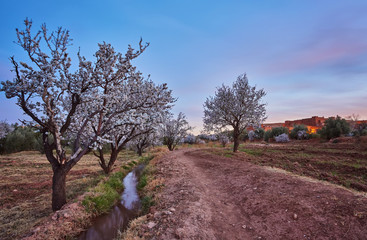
[52,167,67,211]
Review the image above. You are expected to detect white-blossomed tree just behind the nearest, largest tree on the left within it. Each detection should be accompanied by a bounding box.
[75,42,175,174]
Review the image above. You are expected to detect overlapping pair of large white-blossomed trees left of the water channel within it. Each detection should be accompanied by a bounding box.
[1,19,187,210]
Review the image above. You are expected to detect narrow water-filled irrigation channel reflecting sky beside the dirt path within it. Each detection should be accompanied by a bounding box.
[79,164,145,240]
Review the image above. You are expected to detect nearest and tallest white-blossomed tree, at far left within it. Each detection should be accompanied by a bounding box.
[1,19,150,211]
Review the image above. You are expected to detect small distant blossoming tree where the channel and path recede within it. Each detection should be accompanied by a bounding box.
[161,112,192,151]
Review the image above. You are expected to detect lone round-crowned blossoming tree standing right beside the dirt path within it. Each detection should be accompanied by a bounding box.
[204,74,266,152]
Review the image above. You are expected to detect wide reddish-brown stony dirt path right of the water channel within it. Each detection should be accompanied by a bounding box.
[149,149,367,239]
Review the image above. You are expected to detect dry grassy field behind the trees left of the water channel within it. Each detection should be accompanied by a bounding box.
[0,152,136,239]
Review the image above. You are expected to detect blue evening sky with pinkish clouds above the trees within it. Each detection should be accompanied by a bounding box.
[0,0,367,133]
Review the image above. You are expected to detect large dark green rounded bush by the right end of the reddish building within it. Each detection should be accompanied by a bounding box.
[318,116,350,140]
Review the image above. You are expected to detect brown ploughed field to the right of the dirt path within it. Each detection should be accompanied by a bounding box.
[208,138,367,192]
